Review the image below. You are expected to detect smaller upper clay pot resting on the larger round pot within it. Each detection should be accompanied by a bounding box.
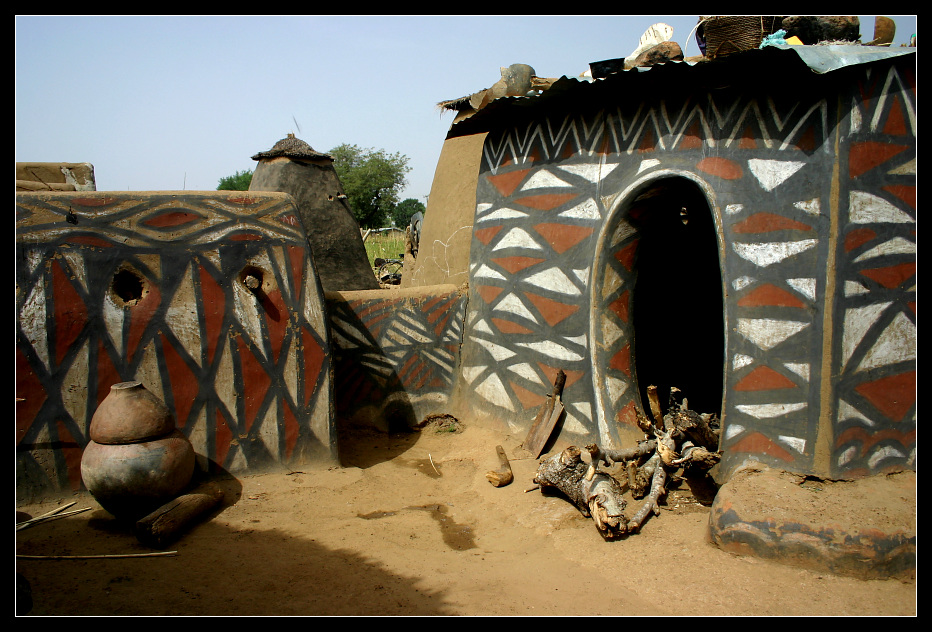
[90,382,175,444]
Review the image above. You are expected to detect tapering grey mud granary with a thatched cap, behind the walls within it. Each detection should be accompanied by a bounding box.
[249,134,379,292]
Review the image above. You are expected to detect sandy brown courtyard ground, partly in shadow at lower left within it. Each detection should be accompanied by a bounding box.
[16,423,917,616]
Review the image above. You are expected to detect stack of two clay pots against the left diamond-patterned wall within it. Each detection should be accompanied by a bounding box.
[81,382,195,520]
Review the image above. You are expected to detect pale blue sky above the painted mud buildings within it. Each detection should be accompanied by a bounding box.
[15,15,916,203]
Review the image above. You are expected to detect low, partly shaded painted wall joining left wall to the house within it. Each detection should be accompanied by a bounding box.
[327,285,466,430]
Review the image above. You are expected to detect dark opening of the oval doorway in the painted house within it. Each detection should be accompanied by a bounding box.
[629,178,725,417]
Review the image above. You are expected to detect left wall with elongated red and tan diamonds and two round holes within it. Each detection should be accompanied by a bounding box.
[16,192,335,502]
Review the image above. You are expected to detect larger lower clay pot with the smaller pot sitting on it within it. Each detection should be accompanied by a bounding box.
[81,430,195,520]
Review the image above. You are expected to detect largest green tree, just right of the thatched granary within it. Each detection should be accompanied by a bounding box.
[327,143,411,228]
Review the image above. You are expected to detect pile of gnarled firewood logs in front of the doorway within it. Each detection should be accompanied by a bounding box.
[534,386,721,539]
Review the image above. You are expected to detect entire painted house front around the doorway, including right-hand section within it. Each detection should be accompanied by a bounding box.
[451,51,916,477]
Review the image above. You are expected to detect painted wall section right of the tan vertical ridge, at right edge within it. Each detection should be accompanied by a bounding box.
[831,59,917,476]
